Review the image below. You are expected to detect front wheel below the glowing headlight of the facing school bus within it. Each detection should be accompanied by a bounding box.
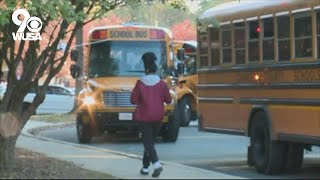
[76,114,92,143]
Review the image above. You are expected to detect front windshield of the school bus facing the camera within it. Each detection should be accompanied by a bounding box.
[89,41,166,78]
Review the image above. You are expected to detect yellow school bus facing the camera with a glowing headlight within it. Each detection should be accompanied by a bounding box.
[76,24,179,143]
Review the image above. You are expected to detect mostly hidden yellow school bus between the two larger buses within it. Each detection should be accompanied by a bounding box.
[173,40,198,126]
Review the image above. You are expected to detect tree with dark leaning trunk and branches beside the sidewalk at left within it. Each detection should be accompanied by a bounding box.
[0,0,125,169]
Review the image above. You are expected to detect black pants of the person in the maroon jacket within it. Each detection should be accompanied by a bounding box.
[140,122,161,168]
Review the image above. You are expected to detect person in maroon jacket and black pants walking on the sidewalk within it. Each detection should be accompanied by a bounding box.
[131,52,171,177]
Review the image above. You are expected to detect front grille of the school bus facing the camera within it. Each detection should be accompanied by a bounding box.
[103,91,134,107]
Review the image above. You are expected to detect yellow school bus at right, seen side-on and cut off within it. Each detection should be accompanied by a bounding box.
[197,0,320,174]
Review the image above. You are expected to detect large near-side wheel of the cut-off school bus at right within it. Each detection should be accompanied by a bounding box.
[248,112,286,174]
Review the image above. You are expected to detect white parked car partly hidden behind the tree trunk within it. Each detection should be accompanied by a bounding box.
[0,85,74,114]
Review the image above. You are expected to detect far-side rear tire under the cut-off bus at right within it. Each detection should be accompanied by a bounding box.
[285,143,304,173]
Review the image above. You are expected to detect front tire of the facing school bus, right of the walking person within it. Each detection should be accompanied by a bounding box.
[161,110,180,142]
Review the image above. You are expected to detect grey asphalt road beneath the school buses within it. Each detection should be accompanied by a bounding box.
[40,126,320,179]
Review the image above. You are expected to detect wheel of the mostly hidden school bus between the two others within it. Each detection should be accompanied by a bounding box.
[179,97,192,126]
